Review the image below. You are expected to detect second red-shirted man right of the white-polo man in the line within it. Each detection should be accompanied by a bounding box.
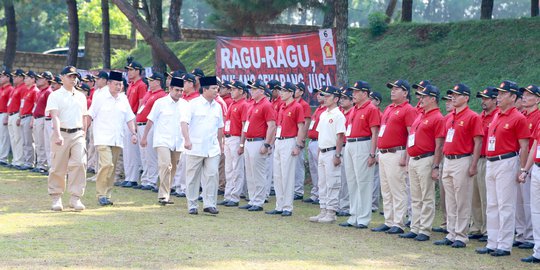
[372,80,416,234]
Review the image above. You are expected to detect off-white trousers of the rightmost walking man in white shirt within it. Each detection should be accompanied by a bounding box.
[185,154,220,209]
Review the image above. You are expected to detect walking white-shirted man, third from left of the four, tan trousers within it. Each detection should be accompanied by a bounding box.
[141,77,189,205]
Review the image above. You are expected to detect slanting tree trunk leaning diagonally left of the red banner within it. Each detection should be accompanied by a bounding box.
[111,0,186,70]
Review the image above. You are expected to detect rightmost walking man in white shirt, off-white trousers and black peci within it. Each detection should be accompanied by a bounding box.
[181,77,224,215]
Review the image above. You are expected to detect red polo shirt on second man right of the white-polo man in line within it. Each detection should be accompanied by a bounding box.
[378,101,416,149]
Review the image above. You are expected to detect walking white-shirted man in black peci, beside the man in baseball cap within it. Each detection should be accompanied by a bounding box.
[88,71,137,206]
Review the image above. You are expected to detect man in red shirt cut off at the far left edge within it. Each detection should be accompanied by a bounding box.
[0,69,13,166]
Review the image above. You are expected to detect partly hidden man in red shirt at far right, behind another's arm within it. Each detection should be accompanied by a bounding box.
[513,85,540,249]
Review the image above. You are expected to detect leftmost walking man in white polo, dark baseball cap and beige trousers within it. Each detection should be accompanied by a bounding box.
[45,66,88,211]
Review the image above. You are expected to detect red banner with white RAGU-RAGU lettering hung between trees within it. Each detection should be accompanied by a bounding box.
[216,29,336,92]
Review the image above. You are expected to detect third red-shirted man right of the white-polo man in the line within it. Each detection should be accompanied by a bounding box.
[399,85,445,241]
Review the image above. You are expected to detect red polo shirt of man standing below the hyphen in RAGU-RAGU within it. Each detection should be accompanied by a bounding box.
[244,98,276,138]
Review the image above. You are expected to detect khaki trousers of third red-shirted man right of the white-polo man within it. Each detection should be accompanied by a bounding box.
[409,156,435,236]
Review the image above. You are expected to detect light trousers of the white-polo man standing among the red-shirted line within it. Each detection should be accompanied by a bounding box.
[318,150,342,211]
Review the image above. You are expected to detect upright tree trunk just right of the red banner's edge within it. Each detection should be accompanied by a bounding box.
[334,0,349,85]
